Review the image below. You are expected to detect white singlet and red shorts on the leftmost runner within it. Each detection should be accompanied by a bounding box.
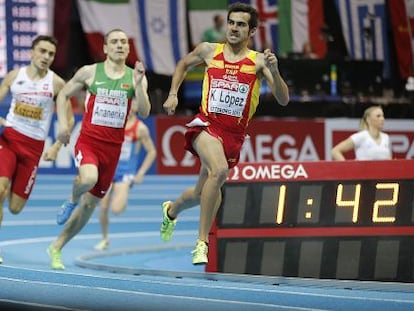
[0,67,55,199]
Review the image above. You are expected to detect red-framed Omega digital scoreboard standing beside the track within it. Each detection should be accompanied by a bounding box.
[206,160,414,282]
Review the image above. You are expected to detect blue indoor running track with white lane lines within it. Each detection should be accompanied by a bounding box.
[0,175,414,311]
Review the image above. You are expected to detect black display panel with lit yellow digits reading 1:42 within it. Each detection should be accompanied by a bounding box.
[222,180,414,227]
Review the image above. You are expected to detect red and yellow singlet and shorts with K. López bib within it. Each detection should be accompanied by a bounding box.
[185,44,261,168]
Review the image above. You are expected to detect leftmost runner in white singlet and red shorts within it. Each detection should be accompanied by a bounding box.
[0,35,74,263]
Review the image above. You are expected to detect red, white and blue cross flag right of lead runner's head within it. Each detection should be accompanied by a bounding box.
[229,0,280,52]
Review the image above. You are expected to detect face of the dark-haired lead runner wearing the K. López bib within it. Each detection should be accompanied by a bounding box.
[226,12,251,44]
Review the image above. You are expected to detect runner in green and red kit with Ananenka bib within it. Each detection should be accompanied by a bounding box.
[48,29,151,270]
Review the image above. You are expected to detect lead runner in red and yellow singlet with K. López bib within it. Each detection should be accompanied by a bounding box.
[160,3,289,265]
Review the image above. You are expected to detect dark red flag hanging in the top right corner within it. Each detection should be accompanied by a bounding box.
[388,0,414,79]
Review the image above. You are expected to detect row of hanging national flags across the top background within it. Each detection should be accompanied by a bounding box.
[78,0,414,78]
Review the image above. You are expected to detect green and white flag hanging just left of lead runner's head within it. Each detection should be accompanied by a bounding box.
[187,0,228,45]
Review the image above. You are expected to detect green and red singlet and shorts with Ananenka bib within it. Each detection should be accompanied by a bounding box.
[75,63,135,198]
